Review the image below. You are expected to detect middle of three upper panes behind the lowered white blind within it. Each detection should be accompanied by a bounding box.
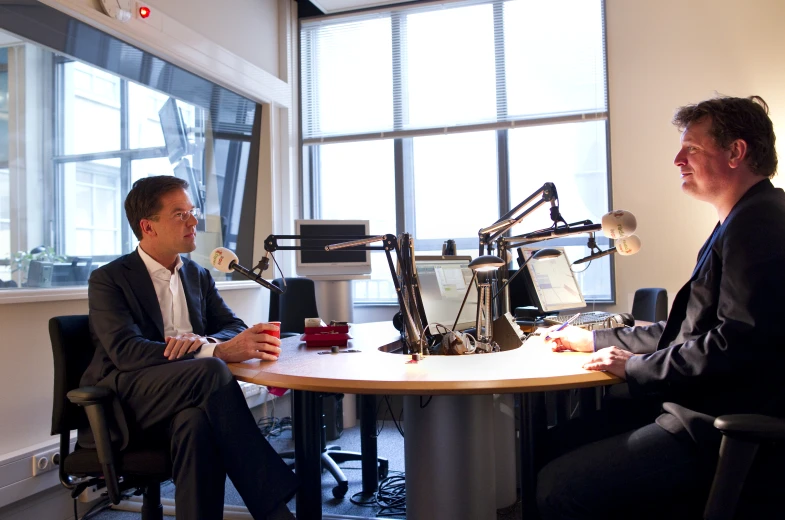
[404,4,496,128]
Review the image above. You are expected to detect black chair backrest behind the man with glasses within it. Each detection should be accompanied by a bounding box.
[49,315,95,435]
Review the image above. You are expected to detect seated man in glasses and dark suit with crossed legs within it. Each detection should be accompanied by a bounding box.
[80,176,297,520]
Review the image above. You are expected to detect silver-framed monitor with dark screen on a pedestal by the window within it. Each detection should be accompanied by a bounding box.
[294,220,370,276]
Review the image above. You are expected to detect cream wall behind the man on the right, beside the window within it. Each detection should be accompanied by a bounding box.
[606,0,785,311]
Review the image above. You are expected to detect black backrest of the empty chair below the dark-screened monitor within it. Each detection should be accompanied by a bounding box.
[269,278,319,333]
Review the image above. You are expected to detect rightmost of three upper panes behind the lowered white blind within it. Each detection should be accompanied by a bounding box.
[504,0,607,116]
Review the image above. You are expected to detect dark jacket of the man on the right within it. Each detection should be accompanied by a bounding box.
[595,180,785,449]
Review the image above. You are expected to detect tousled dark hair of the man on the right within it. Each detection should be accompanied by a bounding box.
[673,96,777,177]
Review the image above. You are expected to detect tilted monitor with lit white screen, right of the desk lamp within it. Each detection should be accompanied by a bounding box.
[520,247,586,313]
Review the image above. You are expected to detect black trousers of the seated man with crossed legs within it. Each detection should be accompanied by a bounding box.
[117,358,297,520]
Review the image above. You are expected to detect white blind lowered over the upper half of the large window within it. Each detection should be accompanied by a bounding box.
[300,0,608,145]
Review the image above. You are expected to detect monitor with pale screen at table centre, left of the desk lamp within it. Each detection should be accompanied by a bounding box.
[414,256,477,333]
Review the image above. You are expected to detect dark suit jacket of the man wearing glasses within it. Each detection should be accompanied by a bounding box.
[79,251,247,447]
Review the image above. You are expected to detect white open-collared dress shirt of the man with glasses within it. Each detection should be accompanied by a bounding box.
[136,246,215,358]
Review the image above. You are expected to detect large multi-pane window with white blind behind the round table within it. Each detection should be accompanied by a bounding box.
[300,0,613,303]
